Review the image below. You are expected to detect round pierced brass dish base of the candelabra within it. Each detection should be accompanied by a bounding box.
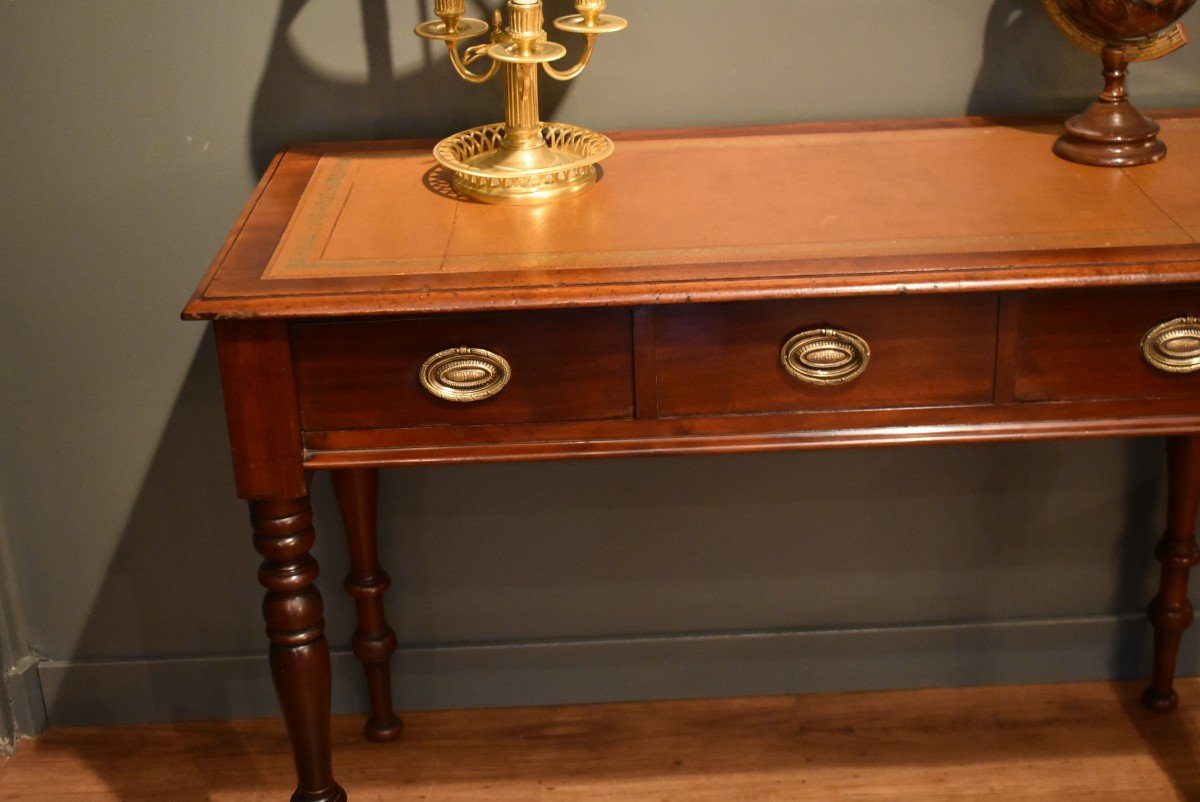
[433,122,613,205]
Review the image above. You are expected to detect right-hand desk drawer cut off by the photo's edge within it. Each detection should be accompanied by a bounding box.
[1014,286,1200,408]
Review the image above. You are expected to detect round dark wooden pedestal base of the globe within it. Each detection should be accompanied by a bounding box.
[1054,100,1166,167]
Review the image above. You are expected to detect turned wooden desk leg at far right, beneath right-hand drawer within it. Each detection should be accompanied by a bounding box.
[1142,436,1200,711]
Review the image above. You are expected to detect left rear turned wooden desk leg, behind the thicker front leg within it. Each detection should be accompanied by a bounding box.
[332,468,401,741]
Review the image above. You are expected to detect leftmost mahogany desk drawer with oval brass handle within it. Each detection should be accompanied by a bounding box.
[292,310,634,431]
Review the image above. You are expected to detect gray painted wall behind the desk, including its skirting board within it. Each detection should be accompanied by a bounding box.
[0,0,1200,724]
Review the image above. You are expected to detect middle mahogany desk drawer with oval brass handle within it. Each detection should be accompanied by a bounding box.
[655,294,997,415]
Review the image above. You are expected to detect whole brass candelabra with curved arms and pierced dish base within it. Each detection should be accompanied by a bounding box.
[415,0,629,205]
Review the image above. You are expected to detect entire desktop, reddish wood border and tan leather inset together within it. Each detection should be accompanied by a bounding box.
[185,114,1200,318]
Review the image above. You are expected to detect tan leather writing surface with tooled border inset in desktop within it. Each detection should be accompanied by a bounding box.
[264,119,1200,279]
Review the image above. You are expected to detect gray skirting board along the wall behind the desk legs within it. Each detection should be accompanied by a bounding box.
[38,615,1200,726]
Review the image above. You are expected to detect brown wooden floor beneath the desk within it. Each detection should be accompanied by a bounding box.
[0,680,1200,802]
